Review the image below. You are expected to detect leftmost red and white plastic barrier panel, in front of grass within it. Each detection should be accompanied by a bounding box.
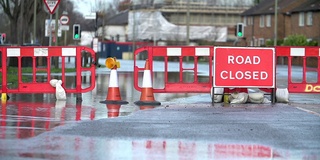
[0,46,96,93]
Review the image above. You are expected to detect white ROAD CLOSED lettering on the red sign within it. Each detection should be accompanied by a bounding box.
[220,55,268,80]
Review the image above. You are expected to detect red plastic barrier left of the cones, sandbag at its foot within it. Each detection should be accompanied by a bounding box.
[0,46,95,96]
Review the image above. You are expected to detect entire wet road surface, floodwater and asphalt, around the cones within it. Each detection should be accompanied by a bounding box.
[0,59,320,160]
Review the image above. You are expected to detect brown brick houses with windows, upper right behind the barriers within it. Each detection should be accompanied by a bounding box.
[241,0,320,46]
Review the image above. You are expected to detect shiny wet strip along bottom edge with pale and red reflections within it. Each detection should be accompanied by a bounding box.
[0,135,316,160]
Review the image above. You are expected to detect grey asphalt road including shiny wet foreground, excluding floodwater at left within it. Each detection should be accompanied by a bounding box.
[0,100,320,159]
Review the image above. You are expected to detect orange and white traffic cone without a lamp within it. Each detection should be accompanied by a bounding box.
[134,59,161,105]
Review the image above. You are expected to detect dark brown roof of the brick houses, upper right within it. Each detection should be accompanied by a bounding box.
[241,0,320,16]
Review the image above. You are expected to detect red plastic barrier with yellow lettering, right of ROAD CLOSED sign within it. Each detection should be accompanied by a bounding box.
[275,46,320,93]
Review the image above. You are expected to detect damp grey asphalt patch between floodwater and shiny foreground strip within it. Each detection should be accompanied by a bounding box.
[56,104,320,150]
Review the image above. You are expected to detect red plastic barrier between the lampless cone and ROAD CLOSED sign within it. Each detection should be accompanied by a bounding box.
[134,46,213,93]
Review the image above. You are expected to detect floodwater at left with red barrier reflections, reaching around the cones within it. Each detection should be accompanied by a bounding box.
[0,72,202,139]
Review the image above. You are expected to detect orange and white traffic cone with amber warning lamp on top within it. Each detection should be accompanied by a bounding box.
[100,58,128,104]
